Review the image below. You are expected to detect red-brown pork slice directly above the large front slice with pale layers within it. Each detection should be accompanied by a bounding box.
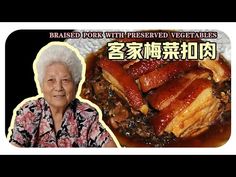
[147,69,211,110]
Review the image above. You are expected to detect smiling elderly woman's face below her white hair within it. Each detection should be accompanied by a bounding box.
[42,63,77,111]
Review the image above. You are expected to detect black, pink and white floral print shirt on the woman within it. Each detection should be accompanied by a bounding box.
[10,98,111,147]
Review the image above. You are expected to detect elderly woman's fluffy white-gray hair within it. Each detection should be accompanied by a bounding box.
[36,45,82,85]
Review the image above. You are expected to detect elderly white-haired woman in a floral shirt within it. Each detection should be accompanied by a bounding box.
[10,43,116,147]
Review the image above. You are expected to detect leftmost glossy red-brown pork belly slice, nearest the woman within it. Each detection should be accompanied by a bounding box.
[98,58,148,114]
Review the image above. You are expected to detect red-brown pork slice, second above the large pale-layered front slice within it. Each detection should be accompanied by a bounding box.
[139,61,198,92]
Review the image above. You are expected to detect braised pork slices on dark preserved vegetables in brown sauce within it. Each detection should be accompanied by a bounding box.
[67,31,231,147]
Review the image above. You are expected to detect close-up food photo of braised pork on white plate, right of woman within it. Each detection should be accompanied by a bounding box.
[66,30,231,147]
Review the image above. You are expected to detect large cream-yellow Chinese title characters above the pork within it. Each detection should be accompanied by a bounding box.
[107,42,217,60]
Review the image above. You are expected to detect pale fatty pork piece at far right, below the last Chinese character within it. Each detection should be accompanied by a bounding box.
[199,55,231,83]
